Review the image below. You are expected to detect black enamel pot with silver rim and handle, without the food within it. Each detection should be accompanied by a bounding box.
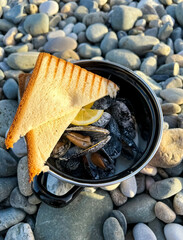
[32,60,163,207]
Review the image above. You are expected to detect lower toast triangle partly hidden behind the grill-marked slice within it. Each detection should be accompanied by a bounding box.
[19,74,80,182]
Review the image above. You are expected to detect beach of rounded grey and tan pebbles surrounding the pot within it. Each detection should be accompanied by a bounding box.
[0,0,183,240]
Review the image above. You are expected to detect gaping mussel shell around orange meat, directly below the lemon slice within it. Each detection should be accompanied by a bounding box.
[60,126,111,160]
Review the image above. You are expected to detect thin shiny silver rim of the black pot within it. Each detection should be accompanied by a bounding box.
[47,59,163,187]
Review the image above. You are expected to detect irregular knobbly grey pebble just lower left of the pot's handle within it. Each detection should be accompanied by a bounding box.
[10,187,37,214]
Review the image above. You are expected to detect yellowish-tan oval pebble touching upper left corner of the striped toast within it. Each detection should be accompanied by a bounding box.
[7,52,39,71]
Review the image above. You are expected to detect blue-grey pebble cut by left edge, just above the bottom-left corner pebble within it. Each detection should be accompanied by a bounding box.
[0,208,26,231]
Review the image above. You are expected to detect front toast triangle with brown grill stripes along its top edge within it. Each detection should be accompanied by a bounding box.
[5,53,119,148]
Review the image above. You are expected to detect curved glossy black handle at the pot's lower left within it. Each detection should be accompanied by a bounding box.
[32,172,83,207]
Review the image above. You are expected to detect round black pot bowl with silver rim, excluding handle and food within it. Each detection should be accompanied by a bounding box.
[47,60,162,186]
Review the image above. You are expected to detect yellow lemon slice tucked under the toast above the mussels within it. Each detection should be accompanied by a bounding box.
[72,108,104,126]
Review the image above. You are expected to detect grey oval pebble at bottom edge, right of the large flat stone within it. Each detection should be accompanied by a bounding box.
[103,217,125,240]
